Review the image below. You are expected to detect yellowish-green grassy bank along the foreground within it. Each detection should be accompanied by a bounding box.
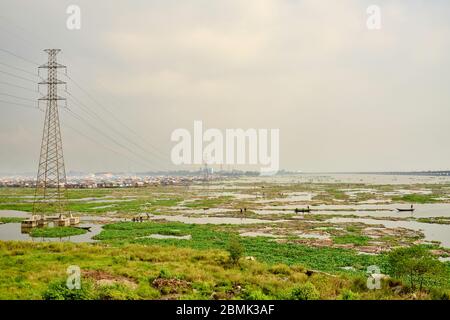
[0,241,449,300]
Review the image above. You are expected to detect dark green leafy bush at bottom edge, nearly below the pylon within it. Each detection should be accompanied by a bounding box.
[42,280,95,300]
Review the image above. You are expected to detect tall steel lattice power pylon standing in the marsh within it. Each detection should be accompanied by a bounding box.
[33,49,66,214]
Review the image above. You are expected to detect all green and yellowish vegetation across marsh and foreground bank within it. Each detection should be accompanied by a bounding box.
[0,183,450,300]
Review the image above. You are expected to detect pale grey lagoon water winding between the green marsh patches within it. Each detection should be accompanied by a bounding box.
[0,174,450,247]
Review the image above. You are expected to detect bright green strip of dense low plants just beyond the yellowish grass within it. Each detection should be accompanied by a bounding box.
[95,222,381,272]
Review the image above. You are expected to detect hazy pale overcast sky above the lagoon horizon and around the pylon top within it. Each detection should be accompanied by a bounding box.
[0,0,450,173]
